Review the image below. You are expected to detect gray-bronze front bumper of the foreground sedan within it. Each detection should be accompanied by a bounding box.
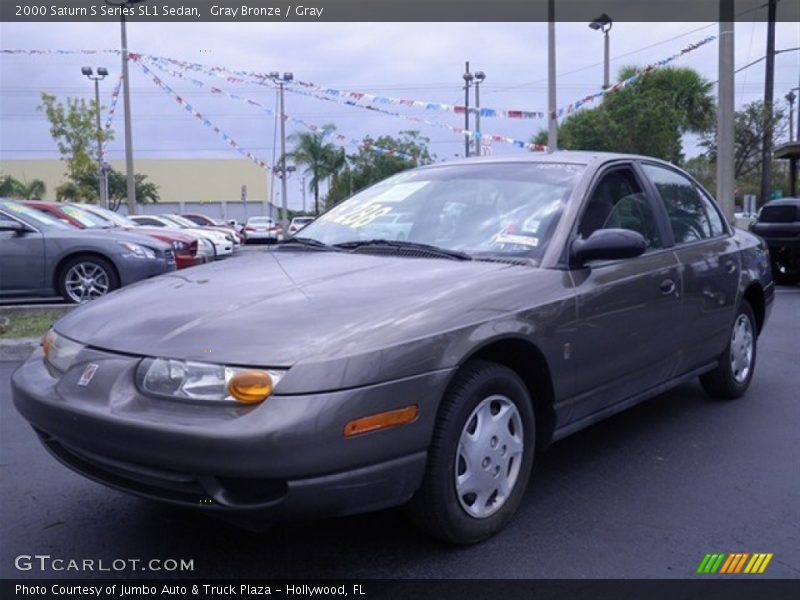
[12,349,451,520]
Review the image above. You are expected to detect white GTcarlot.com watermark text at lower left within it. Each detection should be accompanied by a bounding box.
[14,554,194,573]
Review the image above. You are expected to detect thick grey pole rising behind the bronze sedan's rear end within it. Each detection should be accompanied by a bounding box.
[716,0,736,223]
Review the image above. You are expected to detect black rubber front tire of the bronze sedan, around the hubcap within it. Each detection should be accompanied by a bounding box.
[406,361,536,545]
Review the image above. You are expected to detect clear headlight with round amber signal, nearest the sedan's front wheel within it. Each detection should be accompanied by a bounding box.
[136,358,284,404]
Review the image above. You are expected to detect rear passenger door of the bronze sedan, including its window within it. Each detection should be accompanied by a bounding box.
[641,162,741,373]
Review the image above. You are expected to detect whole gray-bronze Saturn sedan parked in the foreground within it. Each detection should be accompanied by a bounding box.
[12,152,774,543]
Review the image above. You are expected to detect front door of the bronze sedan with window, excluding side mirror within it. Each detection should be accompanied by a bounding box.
[567,162,681,421]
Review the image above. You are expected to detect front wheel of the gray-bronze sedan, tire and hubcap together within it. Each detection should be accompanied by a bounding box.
[407,361,536,544]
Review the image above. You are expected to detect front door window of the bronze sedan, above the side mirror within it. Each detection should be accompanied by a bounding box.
[578,168,662,248]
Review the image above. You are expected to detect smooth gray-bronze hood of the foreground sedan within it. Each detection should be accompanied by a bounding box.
[56,250,560,367]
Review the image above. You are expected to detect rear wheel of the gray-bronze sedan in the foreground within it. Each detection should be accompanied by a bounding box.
[700,300,757,399]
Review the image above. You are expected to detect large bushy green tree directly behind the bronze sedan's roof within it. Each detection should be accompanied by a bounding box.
[532,67,714,164]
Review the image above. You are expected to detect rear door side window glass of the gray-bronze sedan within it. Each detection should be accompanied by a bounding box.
[642,164,725,244]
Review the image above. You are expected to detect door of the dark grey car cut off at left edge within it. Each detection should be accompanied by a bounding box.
[0,211,50,295]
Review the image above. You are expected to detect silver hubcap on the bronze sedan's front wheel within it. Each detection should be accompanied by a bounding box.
[455,395,524,519]
